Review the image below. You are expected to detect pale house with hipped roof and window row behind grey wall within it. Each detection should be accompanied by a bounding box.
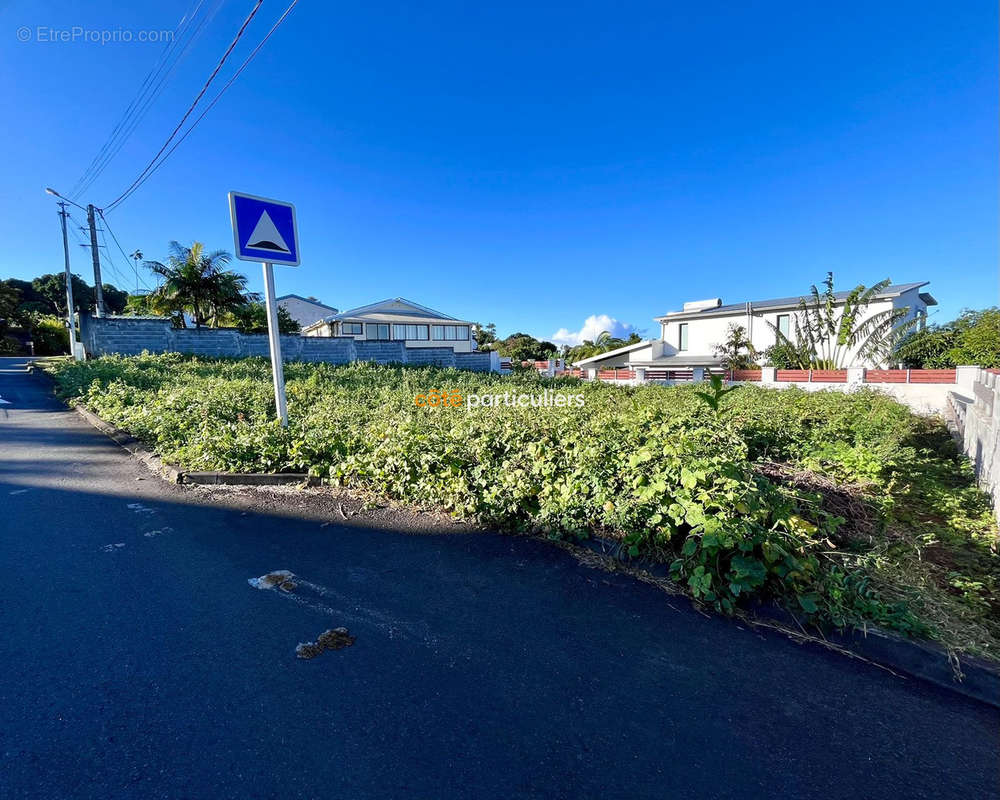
[302,297,476,353]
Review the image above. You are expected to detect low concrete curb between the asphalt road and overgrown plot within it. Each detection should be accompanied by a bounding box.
[32,369,1000,708]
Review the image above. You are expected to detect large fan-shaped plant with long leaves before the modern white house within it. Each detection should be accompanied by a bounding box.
[767,272,917,369]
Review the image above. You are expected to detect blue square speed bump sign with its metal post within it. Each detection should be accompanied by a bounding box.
[229,192,299,427]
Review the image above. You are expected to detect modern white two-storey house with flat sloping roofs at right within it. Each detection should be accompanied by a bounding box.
[575,281,937,370]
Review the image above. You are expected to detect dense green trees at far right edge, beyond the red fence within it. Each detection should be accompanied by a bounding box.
[895,308,1000,369]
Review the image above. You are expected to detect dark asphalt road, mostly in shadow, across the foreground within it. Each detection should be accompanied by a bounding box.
[0,359,1000,800]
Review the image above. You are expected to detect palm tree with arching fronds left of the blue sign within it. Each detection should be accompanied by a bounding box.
[145,242,258,328]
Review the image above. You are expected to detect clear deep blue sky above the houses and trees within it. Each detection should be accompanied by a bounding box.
[0,0,1000,339]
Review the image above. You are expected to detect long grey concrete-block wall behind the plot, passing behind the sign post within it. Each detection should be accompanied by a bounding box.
[80,314,490,372]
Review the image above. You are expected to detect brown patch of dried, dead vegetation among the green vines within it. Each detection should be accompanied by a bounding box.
[754,461,882,545]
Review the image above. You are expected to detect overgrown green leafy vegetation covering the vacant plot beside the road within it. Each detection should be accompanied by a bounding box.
[49,354,1000,659]
